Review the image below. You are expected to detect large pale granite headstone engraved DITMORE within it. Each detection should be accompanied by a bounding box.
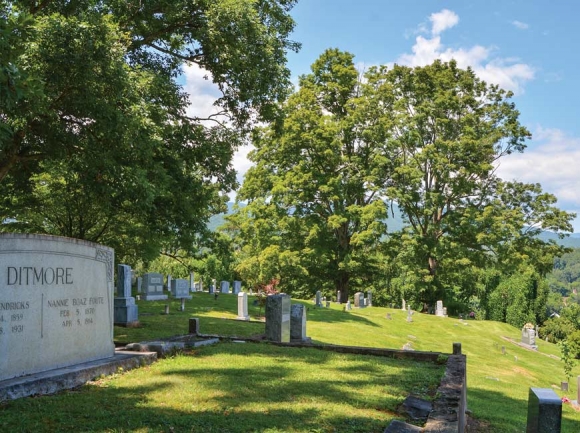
[0,233,115,381]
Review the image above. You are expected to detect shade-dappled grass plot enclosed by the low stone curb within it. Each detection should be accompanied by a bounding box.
[0,343,443,433]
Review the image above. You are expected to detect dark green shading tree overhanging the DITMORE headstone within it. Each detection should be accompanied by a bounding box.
[0,0,298,256]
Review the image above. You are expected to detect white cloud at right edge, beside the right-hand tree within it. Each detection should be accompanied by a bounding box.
[497,127,580,232]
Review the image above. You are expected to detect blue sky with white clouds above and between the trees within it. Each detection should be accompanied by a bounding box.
[185,0,580,232]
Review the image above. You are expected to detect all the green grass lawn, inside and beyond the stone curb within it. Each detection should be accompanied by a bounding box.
[0,293,580,433]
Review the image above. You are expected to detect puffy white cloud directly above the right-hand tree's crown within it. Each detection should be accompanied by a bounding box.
[396,9,534,93]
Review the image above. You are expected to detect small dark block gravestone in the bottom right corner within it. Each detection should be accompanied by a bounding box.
[526,388,562,433]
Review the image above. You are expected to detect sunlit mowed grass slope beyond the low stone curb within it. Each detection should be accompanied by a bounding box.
[115,293,580,433]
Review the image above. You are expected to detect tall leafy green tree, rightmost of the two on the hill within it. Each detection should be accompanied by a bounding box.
[367,61,573,304]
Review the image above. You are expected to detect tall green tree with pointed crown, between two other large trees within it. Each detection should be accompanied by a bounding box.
[233,49,389,302]
